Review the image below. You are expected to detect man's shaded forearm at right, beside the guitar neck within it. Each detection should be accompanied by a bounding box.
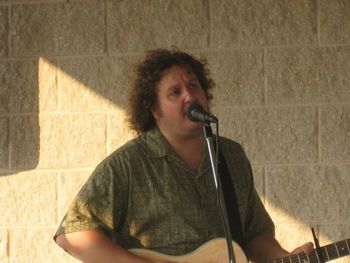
[245,234,289,263]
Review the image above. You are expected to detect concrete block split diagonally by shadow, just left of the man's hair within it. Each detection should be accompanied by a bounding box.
[58,58,134,111]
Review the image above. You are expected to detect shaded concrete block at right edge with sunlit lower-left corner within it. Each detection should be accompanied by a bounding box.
[266,165,350,224]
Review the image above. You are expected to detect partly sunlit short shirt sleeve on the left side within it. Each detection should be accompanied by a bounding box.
[54,157,126,243]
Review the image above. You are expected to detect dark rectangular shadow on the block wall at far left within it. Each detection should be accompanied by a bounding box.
[0,61,40,174]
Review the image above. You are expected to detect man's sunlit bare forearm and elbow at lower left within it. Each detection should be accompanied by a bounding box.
[56,231,149,263]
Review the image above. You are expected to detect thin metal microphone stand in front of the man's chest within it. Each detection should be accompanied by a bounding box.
[203,123,236,263]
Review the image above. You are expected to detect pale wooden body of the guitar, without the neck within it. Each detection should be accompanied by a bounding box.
[129,238,248,263]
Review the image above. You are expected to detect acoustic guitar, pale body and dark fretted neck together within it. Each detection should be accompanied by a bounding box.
[129,238,350,263]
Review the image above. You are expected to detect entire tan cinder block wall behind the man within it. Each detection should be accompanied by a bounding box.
[0,0,350,263]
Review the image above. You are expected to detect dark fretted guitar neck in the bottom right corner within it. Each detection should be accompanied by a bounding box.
[271,239,350,263]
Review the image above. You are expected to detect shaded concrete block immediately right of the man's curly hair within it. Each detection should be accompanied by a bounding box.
[205,50,264,106]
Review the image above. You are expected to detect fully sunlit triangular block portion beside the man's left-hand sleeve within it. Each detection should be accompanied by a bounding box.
[58,170,92,220]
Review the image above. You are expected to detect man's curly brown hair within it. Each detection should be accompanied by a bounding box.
[128,49,215,134]
